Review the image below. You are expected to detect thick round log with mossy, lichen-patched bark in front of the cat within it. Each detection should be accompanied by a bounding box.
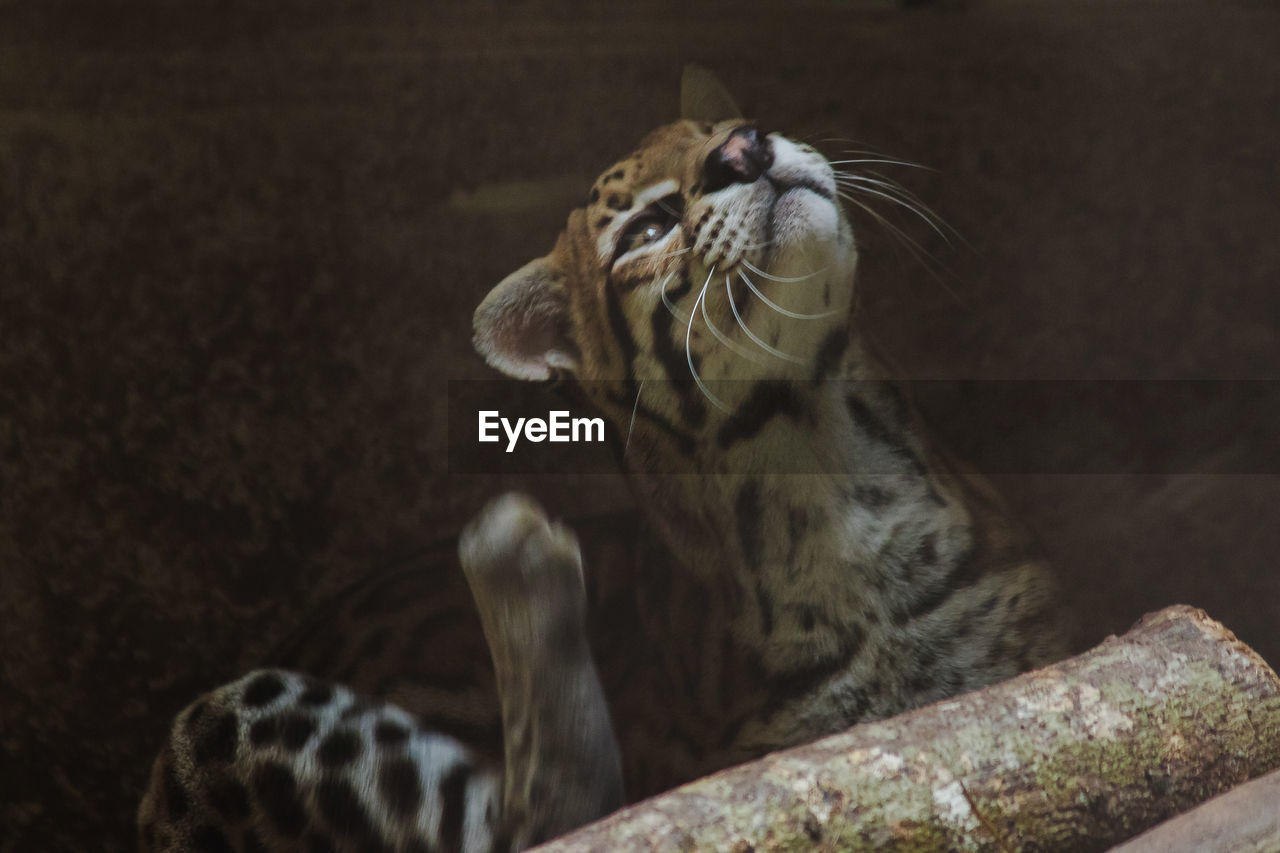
[540,607,1280,853]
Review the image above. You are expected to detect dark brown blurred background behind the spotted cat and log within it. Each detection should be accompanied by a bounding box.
[0,0,1280,852]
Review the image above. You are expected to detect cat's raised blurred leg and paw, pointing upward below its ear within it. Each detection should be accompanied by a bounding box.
[458,494,623,849]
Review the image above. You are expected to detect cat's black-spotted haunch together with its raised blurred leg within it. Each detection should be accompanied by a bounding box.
[138,496,622,853]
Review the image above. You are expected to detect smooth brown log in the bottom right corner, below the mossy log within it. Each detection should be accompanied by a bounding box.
[1111,770,1280,853]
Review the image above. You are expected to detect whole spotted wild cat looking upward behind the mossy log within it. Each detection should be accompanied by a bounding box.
[138,72,1061,852]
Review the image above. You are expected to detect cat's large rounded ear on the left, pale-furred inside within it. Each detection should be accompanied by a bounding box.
[472,257,579,380]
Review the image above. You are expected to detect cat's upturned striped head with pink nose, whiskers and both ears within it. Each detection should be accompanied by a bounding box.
[475,69,856,425]
